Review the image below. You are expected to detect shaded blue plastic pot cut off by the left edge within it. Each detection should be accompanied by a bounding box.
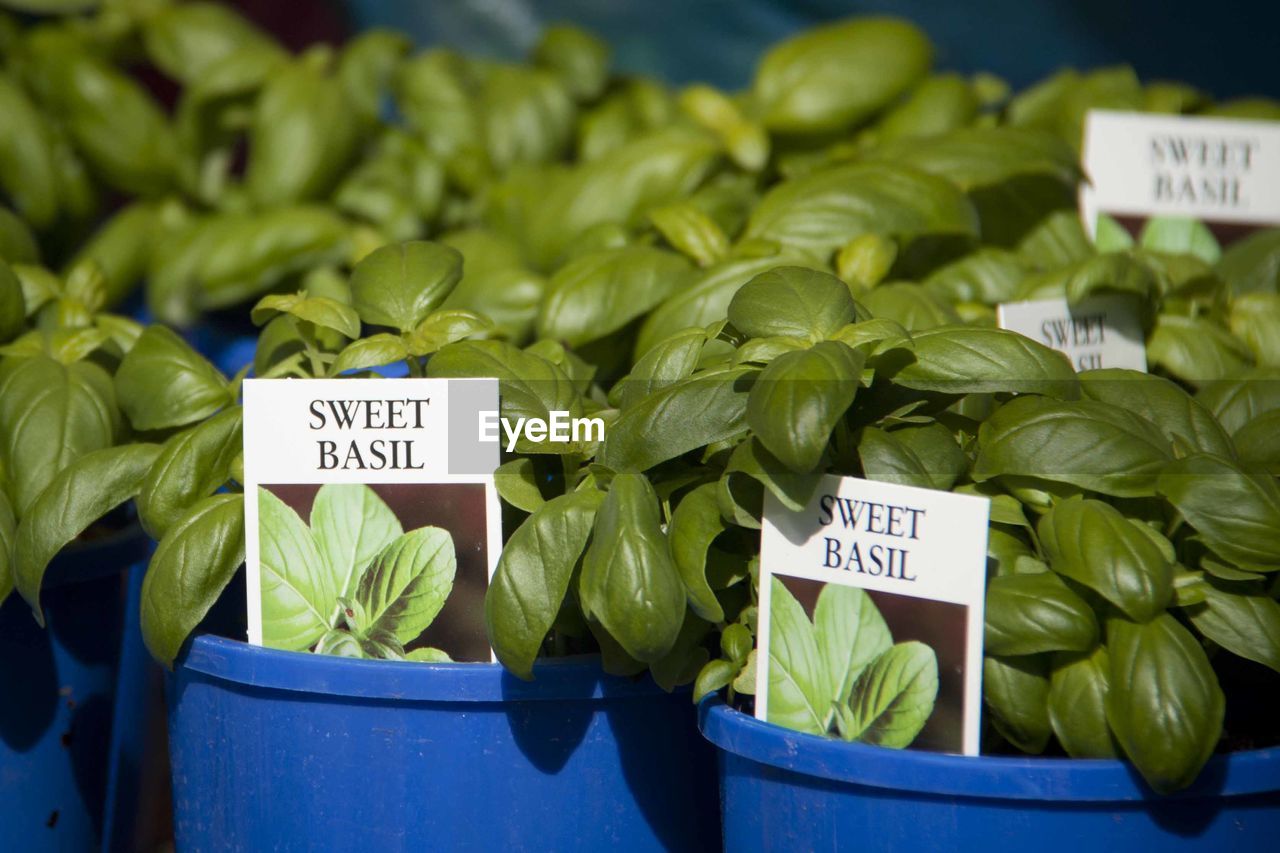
[0,528,148,852]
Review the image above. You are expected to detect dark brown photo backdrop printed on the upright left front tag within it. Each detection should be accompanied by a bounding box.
[264,483,490,662]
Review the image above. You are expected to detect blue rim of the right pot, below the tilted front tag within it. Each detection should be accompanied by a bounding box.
[698,695,1280,802]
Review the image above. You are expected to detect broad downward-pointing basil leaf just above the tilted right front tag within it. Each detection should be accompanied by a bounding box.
[746,338,865,474]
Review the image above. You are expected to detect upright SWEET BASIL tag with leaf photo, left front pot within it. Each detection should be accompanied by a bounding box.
[244,379,502,661]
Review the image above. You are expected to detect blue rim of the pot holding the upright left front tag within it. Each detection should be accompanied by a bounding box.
[175,634,690,703]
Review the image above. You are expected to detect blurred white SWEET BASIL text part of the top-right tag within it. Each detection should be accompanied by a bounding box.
[1080,110,1280,242]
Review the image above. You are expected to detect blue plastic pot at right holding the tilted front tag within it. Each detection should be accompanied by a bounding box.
[699,699,1280,853]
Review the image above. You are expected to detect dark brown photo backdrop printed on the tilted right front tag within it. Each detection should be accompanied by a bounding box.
[774,575,969,753]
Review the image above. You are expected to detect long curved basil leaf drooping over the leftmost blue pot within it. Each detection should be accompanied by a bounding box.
[13,444,160,625]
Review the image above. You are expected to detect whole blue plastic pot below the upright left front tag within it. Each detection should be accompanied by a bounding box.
[168,635,719,852]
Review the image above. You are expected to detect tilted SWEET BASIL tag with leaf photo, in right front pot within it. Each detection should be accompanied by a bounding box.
[755,475,991,756]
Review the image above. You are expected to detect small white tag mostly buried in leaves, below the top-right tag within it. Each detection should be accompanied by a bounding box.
[996,293,1147,373]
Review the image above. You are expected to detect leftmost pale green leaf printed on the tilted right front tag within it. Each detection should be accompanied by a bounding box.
[768,576,832,735]
